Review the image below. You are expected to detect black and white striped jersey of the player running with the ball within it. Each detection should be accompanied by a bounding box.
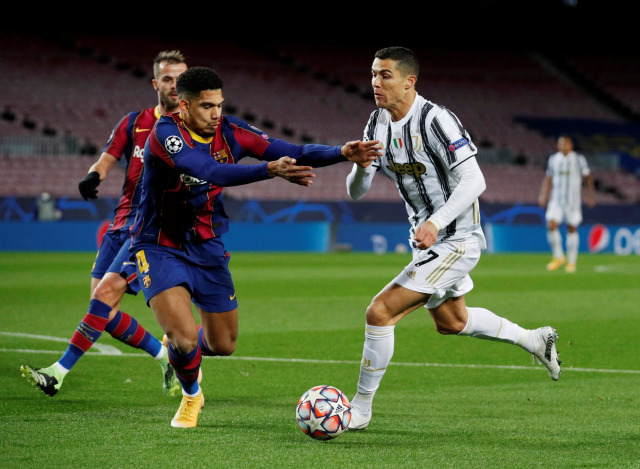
[364,95,482,240]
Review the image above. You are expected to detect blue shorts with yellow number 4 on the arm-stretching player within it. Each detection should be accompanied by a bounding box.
[132,238,238,313]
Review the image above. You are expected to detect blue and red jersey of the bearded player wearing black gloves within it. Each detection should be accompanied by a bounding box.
[103,106,160,230]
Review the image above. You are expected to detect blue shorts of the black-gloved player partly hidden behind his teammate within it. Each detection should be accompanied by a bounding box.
[91,228,140,295]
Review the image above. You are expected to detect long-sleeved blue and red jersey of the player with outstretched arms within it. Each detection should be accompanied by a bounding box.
[131,113,346,249]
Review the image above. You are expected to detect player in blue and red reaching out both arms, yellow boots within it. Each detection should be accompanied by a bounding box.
[131,67,380,427]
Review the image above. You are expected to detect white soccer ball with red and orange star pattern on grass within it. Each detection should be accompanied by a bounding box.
[296,385,351,440]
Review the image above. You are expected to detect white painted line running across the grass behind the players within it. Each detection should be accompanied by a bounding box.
[0,331,640,374]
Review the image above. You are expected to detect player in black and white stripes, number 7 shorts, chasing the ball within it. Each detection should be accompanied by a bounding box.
[346,47,560,430]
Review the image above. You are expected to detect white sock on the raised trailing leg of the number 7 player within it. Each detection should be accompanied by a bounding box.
[459,307,533,353]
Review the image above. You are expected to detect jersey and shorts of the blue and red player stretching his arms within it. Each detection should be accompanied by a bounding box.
[131,113,346,311]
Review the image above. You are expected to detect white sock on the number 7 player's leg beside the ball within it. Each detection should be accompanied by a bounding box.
[352,324,395,412]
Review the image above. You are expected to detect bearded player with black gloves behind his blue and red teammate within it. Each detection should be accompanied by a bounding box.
[20,50,187,396]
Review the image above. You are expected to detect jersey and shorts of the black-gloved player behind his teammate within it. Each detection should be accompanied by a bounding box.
[91,106,160,294]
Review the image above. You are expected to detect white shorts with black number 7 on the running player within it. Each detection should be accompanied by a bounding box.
[393,236,482,309]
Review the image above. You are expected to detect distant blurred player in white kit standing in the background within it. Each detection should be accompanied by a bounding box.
[539,135,595,273]
